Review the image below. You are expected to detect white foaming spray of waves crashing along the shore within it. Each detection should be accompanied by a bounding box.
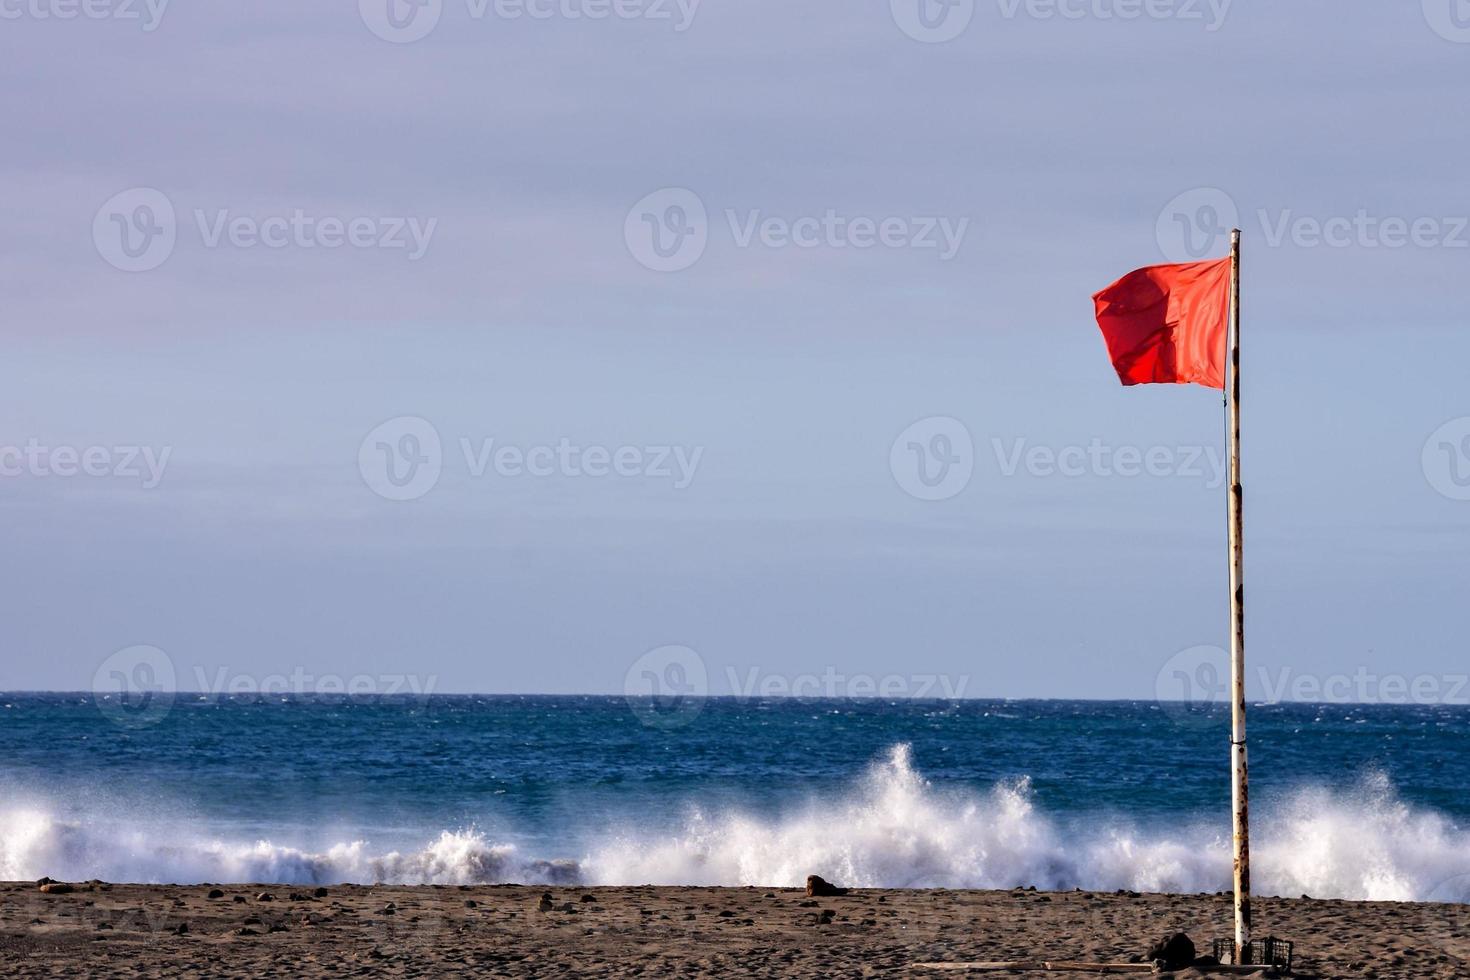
[0,746,1470,902]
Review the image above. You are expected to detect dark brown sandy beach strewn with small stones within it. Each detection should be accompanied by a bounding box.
[0,882,1470,980]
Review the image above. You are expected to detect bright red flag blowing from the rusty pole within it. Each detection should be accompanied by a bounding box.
[1092,259,1230,389]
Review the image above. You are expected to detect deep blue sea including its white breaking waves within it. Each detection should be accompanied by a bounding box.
[0,693,1470,901]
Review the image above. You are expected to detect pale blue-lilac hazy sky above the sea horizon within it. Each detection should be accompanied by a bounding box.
[0,0,1470,702]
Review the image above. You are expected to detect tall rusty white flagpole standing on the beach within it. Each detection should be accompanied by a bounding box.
[1226,229,1251,964]
